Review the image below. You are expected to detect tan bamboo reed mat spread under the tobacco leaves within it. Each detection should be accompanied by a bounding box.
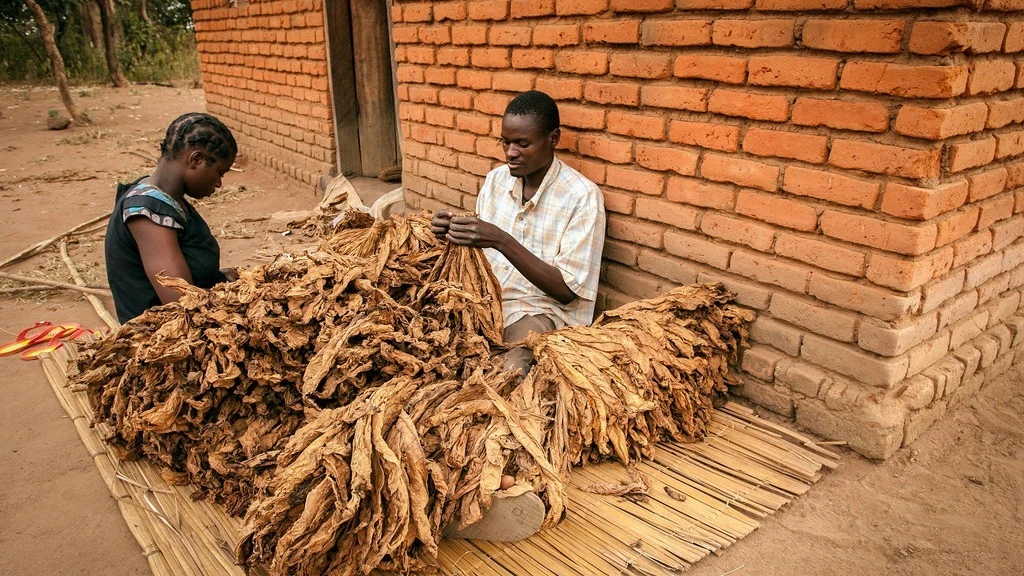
[41,345,839,576]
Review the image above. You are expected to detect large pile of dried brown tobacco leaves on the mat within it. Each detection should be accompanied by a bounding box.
[75,212,751,575]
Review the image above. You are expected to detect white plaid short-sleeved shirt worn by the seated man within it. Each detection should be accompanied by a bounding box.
[476,158,605,328]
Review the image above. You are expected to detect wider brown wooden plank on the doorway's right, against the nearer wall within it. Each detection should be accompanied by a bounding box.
[348,0,398,177]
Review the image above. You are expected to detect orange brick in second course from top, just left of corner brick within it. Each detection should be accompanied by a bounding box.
[801,18,904,54]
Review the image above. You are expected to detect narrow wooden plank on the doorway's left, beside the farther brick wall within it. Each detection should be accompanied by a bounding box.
[324,1,362,174]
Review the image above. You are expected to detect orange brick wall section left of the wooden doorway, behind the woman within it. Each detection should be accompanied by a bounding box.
[191,0,335,184]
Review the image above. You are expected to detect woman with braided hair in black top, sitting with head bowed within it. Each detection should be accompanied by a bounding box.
[103,112,239,323]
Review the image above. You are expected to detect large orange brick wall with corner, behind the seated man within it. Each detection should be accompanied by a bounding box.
[392,0,1024,457]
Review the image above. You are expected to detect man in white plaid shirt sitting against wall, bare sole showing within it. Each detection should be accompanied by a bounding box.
[430,90,605,540]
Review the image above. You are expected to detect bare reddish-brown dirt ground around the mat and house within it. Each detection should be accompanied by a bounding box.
[0,86,1024,576]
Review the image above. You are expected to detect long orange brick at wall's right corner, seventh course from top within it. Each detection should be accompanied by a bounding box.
[820,210,936,255]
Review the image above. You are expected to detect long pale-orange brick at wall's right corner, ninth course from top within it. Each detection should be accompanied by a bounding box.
[808,272,921,322]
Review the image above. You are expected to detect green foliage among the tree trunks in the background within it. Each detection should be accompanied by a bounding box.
[0,0,199,84]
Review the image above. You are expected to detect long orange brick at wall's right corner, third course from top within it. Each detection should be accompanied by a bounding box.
[840,61,968,98]
